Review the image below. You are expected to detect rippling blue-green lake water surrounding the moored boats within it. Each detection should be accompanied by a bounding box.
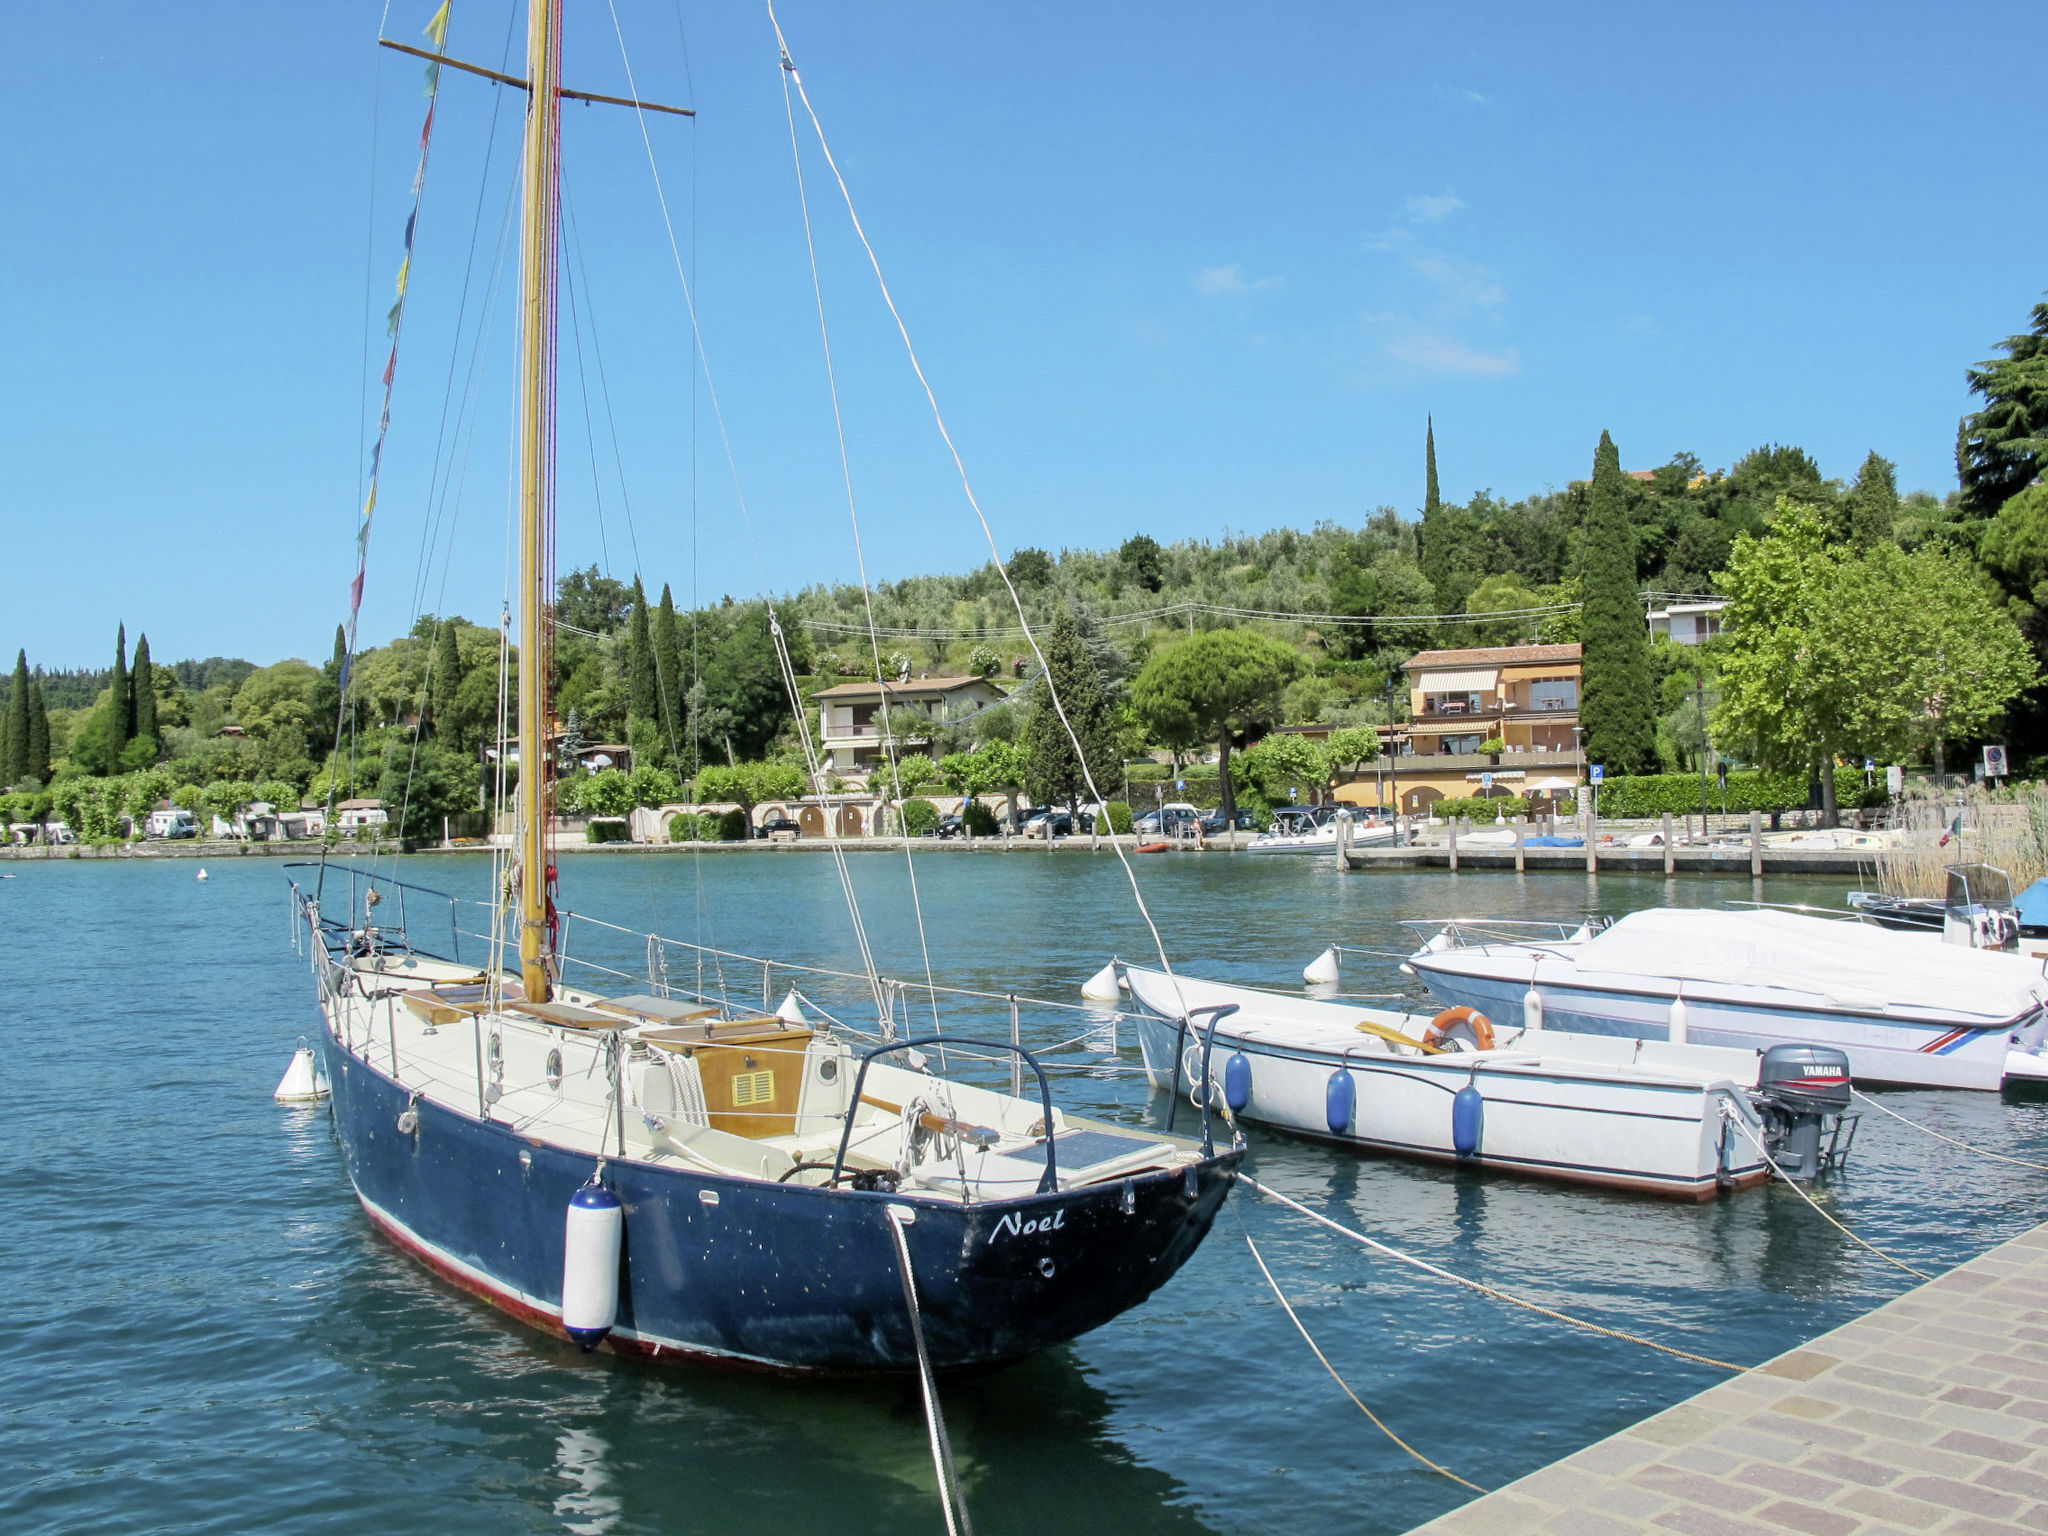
[0,850,2048,1536]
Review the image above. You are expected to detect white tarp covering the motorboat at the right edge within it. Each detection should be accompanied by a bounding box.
[1573,907,2048,1022]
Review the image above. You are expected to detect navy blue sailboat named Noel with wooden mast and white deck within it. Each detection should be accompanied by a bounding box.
[293,0,1243,1374]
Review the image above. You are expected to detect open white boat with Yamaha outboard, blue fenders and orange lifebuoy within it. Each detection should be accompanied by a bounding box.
[1118,965,1849,1200]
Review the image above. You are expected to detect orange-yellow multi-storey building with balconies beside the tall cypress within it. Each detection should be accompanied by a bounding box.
[1337,645,1583,815]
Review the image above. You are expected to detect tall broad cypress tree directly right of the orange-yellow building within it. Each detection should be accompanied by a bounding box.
[1579,432,1657,774]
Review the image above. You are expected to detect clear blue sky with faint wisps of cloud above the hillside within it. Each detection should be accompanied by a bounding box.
[0,0,2048,666]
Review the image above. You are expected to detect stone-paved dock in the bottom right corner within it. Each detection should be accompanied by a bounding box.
[1409,1227,2048,1536]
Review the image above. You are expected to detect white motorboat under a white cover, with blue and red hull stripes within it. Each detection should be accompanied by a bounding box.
[1407,907,2048,1090]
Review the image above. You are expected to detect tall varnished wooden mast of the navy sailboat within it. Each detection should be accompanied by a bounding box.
[518,0,561,1001]
